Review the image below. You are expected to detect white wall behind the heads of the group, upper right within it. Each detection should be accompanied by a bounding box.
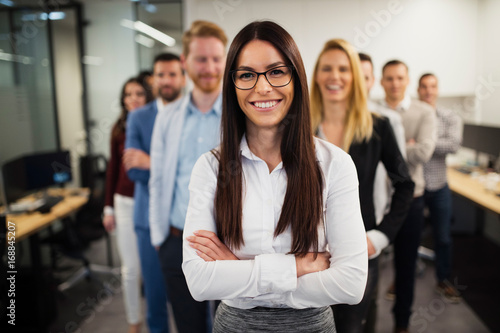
[184,0,476,98]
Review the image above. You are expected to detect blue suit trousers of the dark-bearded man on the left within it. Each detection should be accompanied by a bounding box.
[135,228,168,333]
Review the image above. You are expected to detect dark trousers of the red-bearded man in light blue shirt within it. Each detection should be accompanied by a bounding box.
[158,235,209,333]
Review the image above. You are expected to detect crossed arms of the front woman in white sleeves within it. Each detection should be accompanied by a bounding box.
[182,155,368,308]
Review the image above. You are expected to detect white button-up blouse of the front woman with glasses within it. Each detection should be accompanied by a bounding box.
[182,136,368,309]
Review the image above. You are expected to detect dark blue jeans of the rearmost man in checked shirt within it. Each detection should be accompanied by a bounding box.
[424,185,452,282]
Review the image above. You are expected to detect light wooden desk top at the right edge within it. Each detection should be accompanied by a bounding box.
[448,167,500,214]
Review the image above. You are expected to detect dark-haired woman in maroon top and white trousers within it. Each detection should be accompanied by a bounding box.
[103,78,153,333]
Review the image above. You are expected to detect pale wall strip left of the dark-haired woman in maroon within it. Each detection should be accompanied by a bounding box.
[84,1,138,156]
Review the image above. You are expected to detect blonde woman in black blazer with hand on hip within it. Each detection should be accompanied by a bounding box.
[311,39,414,333]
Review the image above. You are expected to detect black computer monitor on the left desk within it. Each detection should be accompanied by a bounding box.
[2,151,73,204]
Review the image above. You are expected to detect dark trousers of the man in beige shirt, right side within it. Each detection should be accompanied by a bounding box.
[392,196,424,327]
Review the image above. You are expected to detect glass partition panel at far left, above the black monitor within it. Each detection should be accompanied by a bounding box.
[0,9,59,164]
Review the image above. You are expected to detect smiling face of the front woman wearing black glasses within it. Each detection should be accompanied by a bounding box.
[235,40,294,131]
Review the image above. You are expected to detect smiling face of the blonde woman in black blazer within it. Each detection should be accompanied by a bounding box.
[316,49,353,102]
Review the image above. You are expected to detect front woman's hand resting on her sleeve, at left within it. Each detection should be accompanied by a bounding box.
[186,230,239,261]
